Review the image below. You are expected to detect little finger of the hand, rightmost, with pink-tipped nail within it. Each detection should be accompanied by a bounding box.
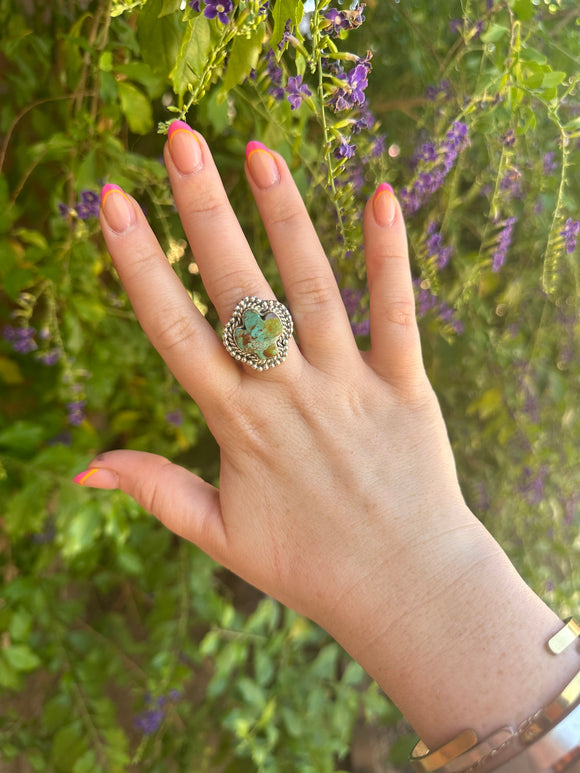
[364,183,425,391]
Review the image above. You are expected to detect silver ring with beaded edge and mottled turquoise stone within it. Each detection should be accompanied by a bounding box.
[222,297,294,371]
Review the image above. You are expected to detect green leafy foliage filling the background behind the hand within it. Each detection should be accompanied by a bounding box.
[0,0,580,773]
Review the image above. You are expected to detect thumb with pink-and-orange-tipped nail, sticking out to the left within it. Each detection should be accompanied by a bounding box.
[74,451,226,563]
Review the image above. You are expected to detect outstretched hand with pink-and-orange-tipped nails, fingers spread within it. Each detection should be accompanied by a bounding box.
[78,122,572,742]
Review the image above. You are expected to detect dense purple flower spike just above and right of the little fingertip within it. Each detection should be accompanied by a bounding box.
[400,121,469,215]
